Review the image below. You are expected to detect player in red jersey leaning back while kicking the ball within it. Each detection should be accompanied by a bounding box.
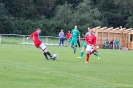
[30,28,54,60]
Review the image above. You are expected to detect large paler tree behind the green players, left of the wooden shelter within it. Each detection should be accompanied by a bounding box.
[72,0,106,32]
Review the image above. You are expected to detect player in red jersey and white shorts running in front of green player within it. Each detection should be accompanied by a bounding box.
[85,29,96,63]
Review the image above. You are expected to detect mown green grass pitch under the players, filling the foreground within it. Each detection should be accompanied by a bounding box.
[0,44,133,88]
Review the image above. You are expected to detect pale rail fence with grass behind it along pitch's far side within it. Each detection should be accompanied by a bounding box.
[0,34,84,46]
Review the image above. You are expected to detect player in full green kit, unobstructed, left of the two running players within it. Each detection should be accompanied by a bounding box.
[71,26,80,53]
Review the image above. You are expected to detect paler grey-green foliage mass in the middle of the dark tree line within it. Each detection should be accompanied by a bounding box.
[54,0,103,33]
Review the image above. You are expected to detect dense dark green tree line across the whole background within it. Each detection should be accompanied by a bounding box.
[0,0,133,35]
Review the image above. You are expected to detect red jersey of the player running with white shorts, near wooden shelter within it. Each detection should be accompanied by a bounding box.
[85,34,96,46]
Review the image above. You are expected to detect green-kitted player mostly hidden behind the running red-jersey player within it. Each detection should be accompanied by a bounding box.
[77,28,100,60]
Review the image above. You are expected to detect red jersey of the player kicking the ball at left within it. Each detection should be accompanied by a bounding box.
[30,31,42,48]
